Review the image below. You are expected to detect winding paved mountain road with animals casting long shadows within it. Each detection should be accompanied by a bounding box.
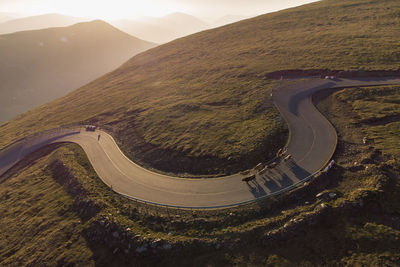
[0,78,400,208]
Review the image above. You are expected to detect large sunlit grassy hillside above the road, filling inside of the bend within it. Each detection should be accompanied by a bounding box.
[0,0,400,176]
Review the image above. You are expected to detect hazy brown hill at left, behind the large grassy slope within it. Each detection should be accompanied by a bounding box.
[0,20,154,123]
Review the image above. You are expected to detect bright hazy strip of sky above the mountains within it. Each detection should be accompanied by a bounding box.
[0,0,316,19]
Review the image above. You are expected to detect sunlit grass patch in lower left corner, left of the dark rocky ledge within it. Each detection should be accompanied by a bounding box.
[0,146,93,266]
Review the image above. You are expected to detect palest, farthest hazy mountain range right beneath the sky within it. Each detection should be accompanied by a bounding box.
[0,12,246,44]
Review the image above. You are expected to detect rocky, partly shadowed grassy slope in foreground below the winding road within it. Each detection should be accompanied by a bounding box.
[0,81,400,266]
